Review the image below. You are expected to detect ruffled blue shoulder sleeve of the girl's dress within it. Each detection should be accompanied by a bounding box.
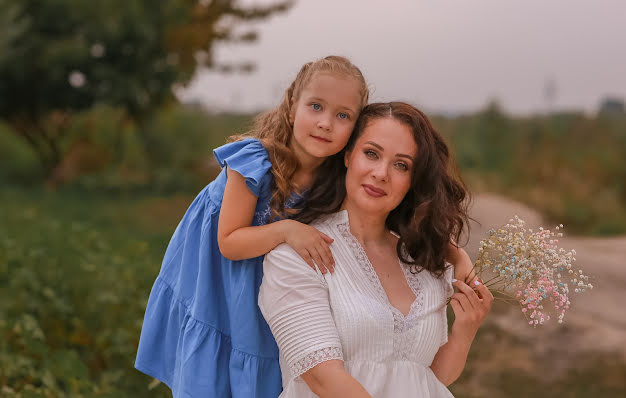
[213,138,272,196]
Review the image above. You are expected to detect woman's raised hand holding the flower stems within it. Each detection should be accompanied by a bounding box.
[450,280,493,344]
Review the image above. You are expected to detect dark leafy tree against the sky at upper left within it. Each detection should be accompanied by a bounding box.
[0,0,292,175]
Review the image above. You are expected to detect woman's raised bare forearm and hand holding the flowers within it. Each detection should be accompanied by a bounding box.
[430,266,493,386]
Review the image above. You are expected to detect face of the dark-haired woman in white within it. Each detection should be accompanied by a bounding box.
[344,117,417,214]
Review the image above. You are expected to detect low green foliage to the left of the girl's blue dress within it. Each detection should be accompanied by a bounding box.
[0,190,181,397]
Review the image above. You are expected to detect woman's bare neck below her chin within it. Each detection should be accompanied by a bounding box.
[341,202,390,245]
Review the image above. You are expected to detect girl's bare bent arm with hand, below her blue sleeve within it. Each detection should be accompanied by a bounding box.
[217,169,334,272]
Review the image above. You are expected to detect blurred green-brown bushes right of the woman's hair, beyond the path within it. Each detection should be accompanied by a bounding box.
[436,106,626,235]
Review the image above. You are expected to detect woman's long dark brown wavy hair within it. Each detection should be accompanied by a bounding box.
[292,102,469,276]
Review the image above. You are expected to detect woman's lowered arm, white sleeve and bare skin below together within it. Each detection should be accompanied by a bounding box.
[259,245,370,398]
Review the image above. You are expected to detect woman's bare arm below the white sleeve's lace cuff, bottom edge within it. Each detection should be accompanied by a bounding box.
[301,359,372,398]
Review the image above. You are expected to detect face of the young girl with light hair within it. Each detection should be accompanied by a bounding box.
[289,72,361,163]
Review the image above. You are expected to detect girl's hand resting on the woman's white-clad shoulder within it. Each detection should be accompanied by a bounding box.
[285,220,335,274]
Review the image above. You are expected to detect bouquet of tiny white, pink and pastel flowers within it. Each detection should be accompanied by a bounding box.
[474,216,593,326]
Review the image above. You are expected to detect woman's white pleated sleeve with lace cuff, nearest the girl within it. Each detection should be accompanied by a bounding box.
[259,244,343,378]
